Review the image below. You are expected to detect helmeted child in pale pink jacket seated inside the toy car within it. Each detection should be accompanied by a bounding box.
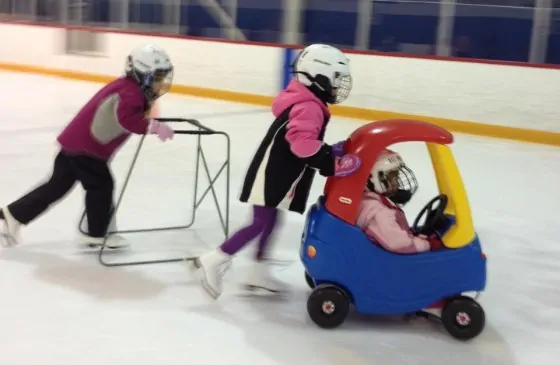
[357,149,442,254]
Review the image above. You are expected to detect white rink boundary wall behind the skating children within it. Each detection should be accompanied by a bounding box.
[0,24,560,132]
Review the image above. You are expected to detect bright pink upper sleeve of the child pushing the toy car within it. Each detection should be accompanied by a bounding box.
[286,101,325,158]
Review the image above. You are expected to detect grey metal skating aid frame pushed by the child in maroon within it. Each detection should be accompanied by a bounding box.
[79,118,230,267]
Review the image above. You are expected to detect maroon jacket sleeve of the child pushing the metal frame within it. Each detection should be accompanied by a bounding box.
[117,92,150,134]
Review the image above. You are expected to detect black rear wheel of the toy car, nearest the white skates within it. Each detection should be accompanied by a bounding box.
[307,285,350,328]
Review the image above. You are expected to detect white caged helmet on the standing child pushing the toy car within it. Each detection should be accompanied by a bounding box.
[292,44,352,104]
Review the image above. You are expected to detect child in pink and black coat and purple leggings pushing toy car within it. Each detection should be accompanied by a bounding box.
[191,44,360,299]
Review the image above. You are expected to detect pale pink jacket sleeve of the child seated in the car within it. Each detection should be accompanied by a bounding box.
[364,201,430,253]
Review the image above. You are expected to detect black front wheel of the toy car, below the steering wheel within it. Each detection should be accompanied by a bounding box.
[441,296,486,340]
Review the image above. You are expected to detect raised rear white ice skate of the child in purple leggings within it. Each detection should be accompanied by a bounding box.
[192,248,231,299]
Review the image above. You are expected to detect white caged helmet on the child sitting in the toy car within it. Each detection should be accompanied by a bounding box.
[367,149,418,204]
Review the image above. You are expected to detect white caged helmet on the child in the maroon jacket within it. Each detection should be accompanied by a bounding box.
[125,44,173,100]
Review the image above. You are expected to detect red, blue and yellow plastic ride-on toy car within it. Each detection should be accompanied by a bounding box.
[300,120,486,339]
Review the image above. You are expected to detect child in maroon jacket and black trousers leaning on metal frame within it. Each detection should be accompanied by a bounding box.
[0,45,174,248]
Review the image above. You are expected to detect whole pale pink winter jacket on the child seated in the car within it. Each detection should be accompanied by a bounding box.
[357,191,430,253]
